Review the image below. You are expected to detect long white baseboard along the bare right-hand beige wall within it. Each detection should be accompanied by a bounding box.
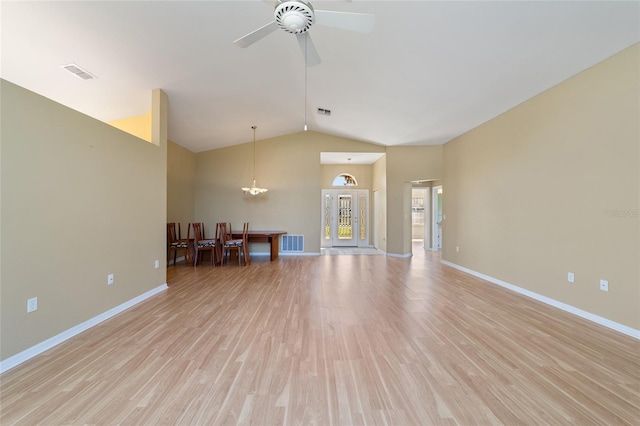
[441,260,640,340]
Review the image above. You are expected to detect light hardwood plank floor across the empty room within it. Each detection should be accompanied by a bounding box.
[0,250,640,425]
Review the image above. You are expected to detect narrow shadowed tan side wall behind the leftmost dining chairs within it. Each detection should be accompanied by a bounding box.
[167,141,196,238]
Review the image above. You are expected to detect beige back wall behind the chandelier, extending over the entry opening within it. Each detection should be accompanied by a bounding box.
[195,131,384,253]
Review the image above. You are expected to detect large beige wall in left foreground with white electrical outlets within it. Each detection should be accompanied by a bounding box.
[0,80,166,360]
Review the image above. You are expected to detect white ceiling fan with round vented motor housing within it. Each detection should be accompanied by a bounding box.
[233,0,375,66]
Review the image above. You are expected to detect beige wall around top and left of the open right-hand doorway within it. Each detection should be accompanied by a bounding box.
[386,145,443,256]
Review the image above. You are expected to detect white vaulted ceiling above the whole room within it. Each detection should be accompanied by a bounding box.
[0,0,640,152]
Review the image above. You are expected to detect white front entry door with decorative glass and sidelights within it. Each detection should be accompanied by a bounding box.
[321,189,371,248]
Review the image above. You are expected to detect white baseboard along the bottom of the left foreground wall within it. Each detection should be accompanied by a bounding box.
[0,283,169,374]
